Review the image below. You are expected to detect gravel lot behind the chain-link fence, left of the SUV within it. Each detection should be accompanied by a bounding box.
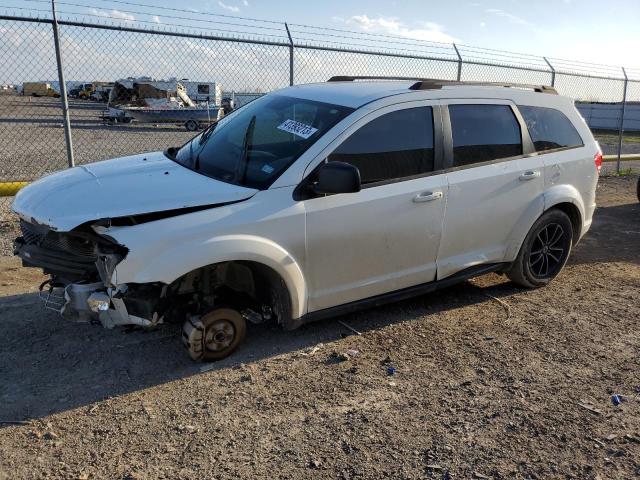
[0,95,194,182]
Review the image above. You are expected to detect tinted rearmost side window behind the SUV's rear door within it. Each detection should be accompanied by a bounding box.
[518,105,583,152]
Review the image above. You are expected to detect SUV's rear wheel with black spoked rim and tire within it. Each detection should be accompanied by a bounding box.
[506,209,573,288]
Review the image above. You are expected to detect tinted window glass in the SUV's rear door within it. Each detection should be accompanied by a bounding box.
[449,104,522,167]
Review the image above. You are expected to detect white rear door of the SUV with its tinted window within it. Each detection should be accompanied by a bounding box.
[438,99,544,278]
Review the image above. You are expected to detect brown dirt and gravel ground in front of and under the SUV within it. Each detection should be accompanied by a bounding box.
[0,177,640,479]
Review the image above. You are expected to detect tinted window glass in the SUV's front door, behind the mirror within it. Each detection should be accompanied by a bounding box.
[329,107,434,185]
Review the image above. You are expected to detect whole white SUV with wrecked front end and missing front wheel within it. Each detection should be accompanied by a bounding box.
[13,77,602,360]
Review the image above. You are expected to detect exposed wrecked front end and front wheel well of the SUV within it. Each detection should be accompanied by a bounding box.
[14,220,289,334]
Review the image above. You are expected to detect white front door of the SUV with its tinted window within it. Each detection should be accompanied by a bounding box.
[305,102,447,311]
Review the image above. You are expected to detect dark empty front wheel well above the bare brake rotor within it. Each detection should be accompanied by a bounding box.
[170,261,291,325]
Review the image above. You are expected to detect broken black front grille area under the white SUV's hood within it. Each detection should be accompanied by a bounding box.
[14,221,98,282]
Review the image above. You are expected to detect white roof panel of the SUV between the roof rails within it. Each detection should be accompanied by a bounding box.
[279,79,563,108]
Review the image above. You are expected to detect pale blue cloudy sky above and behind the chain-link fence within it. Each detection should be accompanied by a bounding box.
[0,0,640,101]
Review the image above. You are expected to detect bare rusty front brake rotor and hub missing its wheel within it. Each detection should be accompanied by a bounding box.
[182,308,247,362]
